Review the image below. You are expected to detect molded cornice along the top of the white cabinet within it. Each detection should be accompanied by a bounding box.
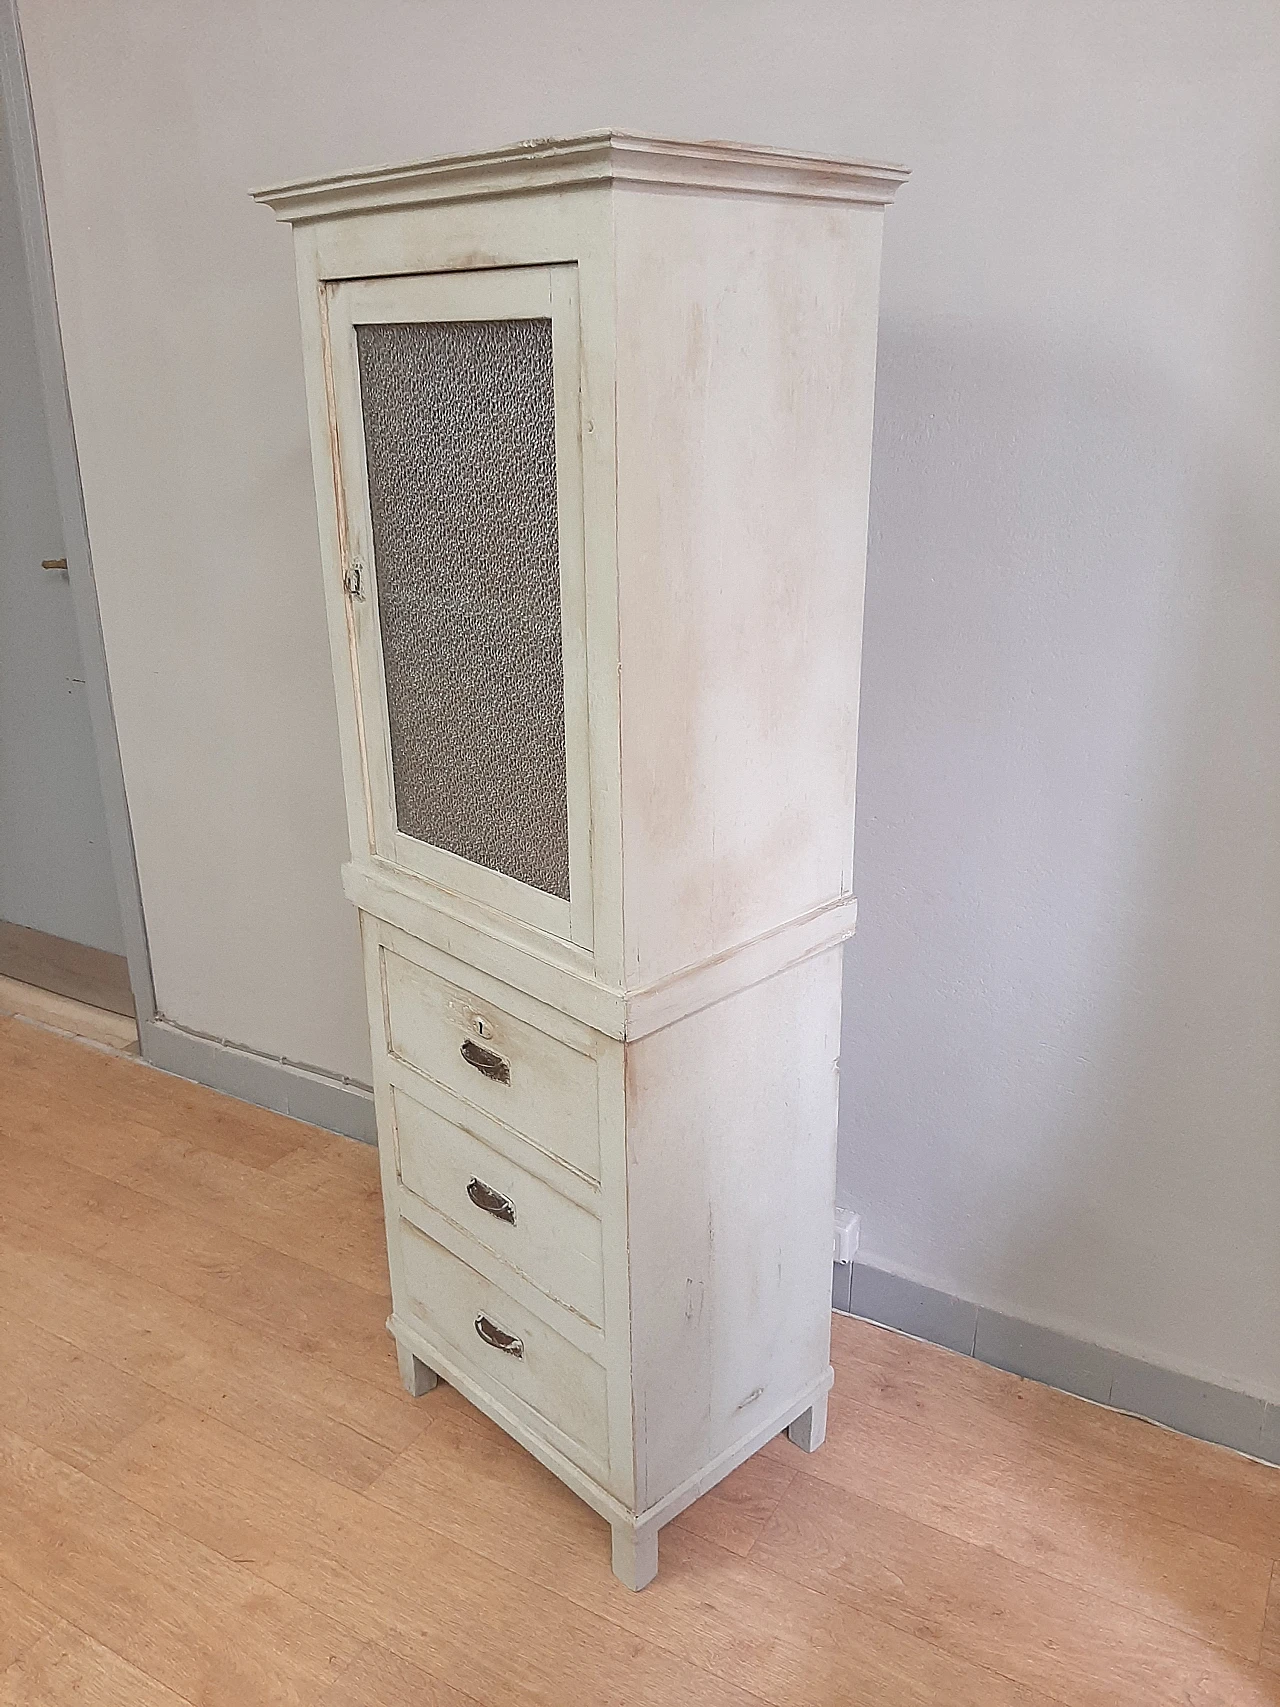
[253,130,908,224]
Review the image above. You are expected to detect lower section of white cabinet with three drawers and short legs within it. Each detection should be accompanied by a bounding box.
[364,915,841,1588]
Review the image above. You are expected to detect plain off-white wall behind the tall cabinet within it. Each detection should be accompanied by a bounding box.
[22,0,1280,1398]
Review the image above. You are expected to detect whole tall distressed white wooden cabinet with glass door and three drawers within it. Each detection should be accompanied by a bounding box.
[259,131,905,1588]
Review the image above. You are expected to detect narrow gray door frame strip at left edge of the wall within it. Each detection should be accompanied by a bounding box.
[0,0,157,1024]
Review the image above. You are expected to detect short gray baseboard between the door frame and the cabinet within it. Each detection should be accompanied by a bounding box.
[138,1019,377,1144]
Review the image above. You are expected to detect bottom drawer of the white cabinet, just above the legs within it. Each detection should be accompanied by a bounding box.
[399,1217,609,1473]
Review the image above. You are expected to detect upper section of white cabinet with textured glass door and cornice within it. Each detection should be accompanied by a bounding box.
[259,131,906,1012]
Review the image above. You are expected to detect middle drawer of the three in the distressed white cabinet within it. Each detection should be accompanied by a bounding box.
[393,1087,604,1328]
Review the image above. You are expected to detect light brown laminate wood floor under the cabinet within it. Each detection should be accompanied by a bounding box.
[0,1019,1280,1707]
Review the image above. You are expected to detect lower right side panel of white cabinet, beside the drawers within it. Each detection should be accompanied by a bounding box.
[626,949,841,1509]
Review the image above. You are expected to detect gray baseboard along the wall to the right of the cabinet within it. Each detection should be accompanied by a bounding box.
[831,1263,1280,1465]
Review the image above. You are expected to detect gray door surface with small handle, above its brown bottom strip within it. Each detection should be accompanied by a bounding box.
[0,83,125,954]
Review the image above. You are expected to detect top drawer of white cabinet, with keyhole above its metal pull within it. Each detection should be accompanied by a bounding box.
[382,947,601,1180]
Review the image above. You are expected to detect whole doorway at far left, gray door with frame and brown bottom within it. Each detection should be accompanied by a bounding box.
[0,33,154,1050]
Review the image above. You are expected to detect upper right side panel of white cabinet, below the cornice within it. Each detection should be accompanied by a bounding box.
[616,188,882,985]
